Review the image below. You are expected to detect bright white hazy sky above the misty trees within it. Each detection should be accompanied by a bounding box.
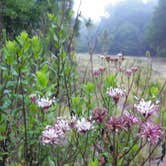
[74,0,150,22]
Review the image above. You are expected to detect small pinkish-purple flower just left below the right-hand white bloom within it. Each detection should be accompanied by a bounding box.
[123,112,139,127]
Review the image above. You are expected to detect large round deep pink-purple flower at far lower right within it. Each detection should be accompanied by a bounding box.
[138,121,162,144]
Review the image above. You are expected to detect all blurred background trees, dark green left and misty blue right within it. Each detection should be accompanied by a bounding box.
[0,0,166,56]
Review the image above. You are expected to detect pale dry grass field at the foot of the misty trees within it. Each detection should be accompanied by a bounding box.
[77,53,166,81]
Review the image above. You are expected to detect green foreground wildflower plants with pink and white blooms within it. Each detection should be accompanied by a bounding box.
[0,11,165,166]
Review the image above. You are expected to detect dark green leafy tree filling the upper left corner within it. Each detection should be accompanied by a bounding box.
[0,0,44,38]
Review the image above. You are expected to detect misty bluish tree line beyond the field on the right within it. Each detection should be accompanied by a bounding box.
[77,0,166,56]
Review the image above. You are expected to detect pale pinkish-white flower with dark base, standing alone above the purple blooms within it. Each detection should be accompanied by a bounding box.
[106,87,126,104]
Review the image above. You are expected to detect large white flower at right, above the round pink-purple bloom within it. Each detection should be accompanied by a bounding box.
[134,99,158,118]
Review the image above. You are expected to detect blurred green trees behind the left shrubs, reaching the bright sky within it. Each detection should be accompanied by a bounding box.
[0,0,73,39]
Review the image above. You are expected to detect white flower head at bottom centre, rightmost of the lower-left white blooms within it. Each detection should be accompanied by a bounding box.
[76,118,93,132]
